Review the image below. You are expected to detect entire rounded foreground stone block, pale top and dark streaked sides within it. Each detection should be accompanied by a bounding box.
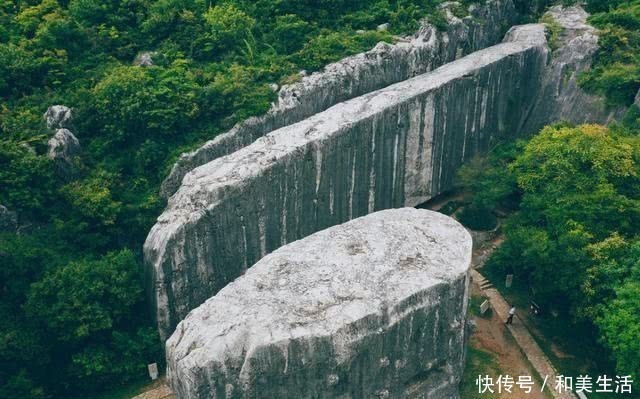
[167,209,471,399]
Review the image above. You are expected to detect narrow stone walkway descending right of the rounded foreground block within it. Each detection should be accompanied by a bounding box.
[471,269,577,399]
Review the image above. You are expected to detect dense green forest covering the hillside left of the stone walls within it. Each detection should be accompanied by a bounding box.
[0,0,484,398]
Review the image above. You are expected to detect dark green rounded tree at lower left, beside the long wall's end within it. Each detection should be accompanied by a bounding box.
[26,250,158,390]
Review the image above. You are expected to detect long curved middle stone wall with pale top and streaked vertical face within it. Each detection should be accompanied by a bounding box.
[144,25,547,338]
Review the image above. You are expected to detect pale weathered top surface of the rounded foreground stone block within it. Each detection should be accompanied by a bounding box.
[167,208,472,378]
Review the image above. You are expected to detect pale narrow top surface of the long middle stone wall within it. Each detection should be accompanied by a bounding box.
[156,28,546,228]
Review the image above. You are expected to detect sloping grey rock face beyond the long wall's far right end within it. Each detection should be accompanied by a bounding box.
[524,6,625,132]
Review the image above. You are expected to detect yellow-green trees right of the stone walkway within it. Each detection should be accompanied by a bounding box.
[462,125,640,378]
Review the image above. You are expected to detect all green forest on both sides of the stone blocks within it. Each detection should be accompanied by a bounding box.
[0,0,640,398]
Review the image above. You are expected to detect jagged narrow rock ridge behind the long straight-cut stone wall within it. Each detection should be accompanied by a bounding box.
[160,0,526,197]
